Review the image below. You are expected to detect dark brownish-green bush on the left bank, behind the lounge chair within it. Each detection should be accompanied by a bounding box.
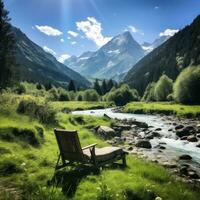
[17,100,56,124]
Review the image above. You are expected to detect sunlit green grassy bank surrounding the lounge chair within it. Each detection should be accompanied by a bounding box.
[0,93,199,200]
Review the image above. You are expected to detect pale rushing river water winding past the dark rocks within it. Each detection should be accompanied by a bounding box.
[72,108,200,169]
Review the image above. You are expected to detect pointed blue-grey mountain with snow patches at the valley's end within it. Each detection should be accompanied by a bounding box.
[65,31,145,80]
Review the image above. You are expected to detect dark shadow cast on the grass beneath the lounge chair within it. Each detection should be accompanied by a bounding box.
[48,163,125,198]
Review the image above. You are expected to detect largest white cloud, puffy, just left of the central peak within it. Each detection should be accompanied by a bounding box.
[76,17,112,47]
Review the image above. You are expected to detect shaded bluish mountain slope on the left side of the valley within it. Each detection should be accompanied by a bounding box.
[13,27,90,87]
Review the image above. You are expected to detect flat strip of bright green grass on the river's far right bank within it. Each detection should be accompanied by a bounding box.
[124,102,200,117]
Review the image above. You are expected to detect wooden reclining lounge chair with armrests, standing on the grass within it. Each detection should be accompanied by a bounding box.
[54,129,126,170]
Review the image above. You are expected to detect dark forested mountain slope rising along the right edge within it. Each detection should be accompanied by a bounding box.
[124,15,200,93]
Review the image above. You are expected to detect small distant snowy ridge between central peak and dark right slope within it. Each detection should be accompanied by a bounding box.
[142,35,170,54]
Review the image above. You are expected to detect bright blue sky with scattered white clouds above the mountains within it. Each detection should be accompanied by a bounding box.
[4,0,200,61]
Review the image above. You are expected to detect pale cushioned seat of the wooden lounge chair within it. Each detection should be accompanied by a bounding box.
[83,147,123,162]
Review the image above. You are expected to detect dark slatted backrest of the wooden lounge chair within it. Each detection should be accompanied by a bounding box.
[54,129,84,162]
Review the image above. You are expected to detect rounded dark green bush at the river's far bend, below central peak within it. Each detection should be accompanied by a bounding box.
[105,85,139,106]
